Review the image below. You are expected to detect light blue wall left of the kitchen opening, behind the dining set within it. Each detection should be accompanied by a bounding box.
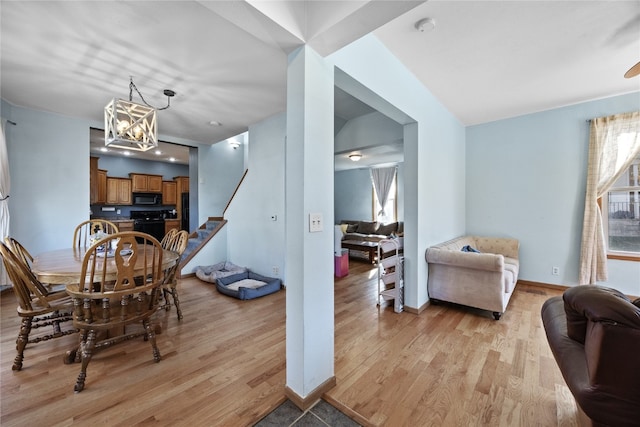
[3,104,89,255]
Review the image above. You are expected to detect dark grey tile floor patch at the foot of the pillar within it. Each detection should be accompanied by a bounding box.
[254,399,360,427]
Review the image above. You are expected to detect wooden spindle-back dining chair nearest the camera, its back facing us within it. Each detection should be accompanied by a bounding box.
[67,231,163,392]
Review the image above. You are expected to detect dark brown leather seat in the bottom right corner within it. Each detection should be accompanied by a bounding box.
[541,285,640,427]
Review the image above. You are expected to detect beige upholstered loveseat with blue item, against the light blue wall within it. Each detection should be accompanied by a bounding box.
[425,236,520,320]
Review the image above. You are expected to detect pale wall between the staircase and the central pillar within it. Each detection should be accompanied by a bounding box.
[225,113,286,278]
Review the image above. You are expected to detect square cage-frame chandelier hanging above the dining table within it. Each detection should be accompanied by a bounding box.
[104,77,176,151]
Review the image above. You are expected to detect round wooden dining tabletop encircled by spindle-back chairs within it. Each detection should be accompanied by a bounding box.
[31,247,179,285]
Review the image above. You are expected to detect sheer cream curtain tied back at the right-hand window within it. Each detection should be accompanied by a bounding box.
[578,111,640,285]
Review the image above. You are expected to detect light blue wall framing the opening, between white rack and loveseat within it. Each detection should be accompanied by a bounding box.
[328,35,465,309]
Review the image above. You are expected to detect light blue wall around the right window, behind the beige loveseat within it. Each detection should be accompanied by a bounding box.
[466,93,640,295]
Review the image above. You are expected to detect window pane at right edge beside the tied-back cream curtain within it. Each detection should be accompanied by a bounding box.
[602,155,640,259]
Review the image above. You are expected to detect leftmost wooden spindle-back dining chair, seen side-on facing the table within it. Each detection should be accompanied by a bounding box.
[0,242,78,371]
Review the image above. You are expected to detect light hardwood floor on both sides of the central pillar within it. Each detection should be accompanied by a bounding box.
[0,260,577,427]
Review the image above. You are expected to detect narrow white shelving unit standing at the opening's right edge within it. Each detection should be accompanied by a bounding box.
[378,238,404,313]
